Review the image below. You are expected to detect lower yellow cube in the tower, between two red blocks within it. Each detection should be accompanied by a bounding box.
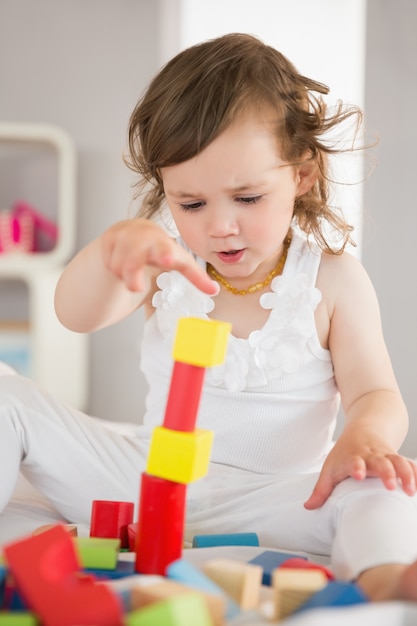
[146,426,213,484]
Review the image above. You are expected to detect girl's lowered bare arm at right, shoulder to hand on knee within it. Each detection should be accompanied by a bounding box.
[305,254,417,509]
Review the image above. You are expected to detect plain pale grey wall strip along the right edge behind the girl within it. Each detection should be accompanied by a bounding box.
[362,0,417,457]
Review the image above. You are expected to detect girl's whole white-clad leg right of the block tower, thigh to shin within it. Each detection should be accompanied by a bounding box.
[186,465,417,580]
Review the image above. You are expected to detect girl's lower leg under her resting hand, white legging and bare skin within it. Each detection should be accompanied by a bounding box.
[332,479,417,601]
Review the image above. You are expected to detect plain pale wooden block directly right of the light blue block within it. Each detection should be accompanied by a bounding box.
[202,559,263,610]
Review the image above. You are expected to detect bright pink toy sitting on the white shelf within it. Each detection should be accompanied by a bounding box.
[0,201,58,253]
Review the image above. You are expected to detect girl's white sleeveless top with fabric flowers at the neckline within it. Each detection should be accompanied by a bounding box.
[142,234,339,474]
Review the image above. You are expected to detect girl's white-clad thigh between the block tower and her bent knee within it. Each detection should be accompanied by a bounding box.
[186,464,333,559]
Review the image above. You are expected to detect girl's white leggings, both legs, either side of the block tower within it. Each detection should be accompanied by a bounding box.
[0,369,417,579]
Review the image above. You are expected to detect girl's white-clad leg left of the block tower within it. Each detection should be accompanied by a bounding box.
[0,375,147,523]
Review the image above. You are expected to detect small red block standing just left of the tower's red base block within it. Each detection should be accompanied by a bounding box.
[90,500,134,548]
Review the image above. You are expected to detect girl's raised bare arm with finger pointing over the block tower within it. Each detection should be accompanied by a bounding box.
[55,218,216,332]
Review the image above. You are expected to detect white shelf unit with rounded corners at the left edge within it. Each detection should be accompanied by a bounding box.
[0,122,88,409]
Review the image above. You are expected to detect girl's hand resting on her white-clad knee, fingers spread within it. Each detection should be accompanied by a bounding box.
[304,435,417,509]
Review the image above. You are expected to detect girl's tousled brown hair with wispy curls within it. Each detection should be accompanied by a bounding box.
[126,33,362,254]
